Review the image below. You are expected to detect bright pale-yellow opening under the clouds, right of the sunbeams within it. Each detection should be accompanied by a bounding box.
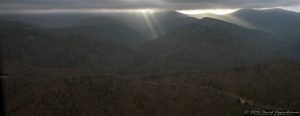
[178,9,239,15]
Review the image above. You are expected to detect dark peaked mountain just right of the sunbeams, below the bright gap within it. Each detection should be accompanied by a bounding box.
[136,18,282,72]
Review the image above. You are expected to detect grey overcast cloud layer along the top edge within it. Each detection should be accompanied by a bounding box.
[0,0,300,12]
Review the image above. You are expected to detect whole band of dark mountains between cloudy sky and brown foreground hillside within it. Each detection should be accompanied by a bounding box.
[0,9,300,72]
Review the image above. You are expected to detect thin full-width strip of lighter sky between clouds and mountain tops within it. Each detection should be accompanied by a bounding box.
[0,7,300,15]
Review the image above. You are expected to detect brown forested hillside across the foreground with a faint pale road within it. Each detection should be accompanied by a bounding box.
[4,60,300,116]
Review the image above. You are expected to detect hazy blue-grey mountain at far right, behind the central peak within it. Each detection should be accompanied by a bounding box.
[193,9,300,43]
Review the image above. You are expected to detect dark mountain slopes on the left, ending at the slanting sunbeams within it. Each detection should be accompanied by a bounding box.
[0,19,146,72]
